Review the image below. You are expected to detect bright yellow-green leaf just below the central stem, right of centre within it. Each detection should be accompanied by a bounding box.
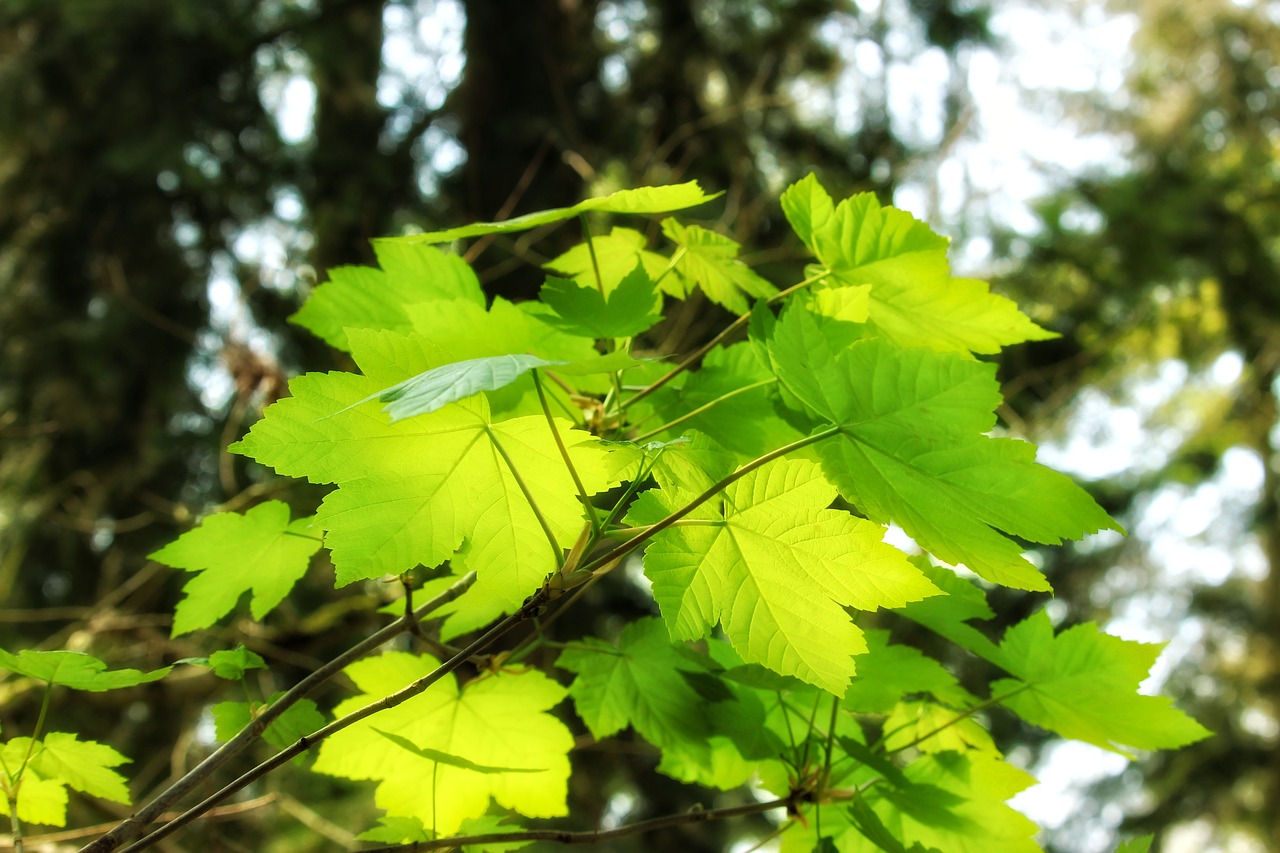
[627,460,938,694]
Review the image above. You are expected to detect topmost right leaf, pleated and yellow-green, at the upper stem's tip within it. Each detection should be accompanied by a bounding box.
[782,174,1056,352]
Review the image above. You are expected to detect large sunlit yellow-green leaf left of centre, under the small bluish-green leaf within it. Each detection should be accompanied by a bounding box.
[233,326,617,619]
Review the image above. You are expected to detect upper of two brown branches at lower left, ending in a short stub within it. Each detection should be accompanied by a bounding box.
[82,573,475,853]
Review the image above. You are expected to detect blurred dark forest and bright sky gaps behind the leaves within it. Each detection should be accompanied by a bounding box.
[0,0,1280,853]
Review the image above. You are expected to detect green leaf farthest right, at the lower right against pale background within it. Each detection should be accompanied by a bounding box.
[991,610,1211,754]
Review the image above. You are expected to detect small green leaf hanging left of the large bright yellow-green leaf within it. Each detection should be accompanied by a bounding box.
[151,501,321,637]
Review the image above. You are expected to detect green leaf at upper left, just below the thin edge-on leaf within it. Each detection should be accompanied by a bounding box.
[289,241,485,351]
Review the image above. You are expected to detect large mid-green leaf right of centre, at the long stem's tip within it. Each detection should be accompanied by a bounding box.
[768,306,1123,590]
